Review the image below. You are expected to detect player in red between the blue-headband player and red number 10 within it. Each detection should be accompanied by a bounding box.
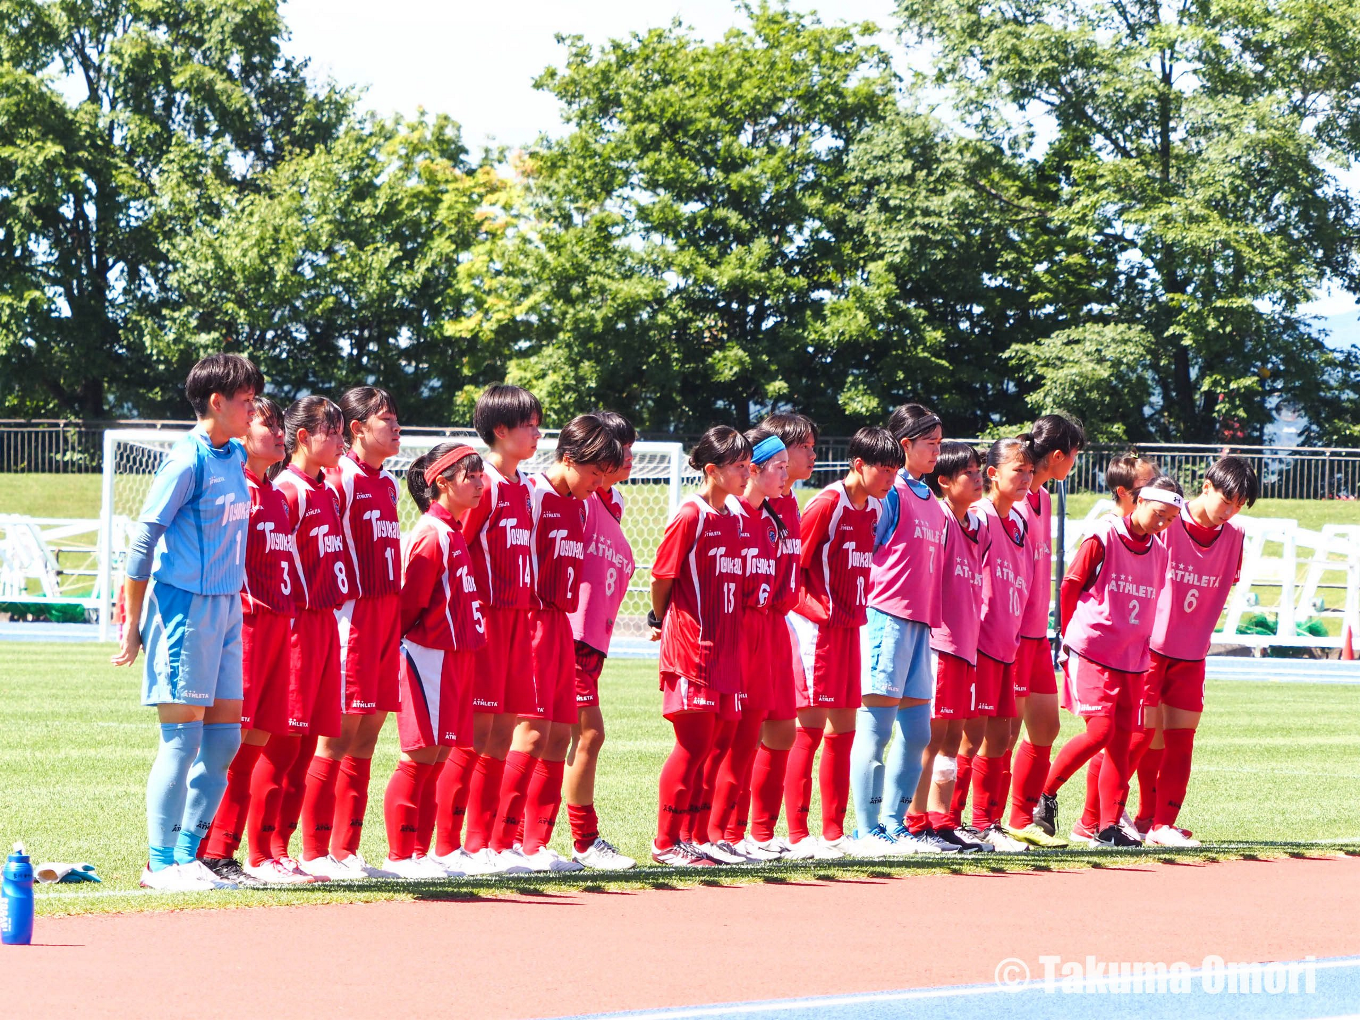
[729,411,817,861]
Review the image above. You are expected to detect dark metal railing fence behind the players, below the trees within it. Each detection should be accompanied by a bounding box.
[0,419,1360,499]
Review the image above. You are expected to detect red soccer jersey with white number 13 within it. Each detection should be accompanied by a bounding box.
[651,496,745,694]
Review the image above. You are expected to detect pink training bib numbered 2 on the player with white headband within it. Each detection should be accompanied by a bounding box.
[1064,518,1167,673]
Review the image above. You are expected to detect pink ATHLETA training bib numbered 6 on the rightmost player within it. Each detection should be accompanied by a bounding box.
[1152,510,1246,662]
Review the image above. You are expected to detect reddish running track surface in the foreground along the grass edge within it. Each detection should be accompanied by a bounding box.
[0,857,1360,1020]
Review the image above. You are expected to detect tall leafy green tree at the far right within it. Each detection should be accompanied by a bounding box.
[898,0,1360,441]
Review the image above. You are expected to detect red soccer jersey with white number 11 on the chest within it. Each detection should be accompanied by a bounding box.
[326,450,401,598]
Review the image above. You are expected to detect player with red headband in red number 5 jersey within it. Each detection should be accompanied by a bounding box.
[382,442,487,879]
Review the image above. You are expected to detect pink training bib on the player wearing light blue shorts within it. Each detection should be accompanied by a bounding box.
[869,472,945,627]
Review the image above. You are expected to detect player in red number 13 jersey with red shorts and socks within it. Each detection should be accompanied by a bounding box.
[647,426,751,868]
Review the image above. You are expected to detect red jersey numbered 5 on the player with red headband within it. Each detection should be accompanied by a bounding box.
[401,503,487,651]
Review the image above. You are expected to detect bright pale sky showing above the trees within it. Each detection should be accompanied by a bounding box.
[283,0,1360,344]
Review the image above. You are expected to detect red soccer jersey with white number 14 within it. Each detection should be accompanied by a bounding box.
[462,461,534,609]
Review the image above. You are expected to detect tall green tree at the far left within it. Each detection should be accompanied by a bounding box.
[0,0,350,418]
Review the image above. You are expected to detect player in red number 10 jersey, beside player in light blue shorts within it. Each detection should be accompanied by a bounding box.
[785,428,906,858]
